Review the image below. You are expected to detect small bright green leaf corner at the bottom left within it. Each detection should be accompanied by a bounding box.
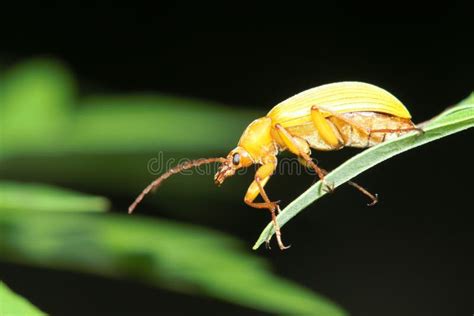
[0,281,46,316]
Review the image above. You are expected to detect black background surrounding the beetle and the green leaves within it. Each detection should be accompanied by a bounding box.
[0,2,474,315]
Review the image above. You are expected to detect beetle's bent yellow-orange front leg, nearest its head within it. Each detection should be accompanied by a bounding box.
[244,163,289,250]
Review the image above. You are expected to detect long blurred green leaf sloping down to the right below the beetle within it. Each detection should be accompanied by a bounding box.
[0,209,345,315]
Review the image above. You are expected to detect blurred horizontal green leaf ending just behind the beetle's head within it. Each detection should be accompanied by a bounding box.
[69,94,262,155]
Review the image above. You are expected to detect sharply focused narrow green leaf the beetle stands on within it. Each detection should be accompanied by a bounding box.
[253,94,474,250]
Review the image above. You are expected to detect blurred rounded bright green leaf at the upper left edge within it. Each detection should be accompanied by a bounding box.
[0,60,75,156]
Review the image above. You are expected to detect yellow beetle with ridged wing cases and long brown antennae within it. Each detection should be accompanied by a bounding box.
[129,82,419,249]
